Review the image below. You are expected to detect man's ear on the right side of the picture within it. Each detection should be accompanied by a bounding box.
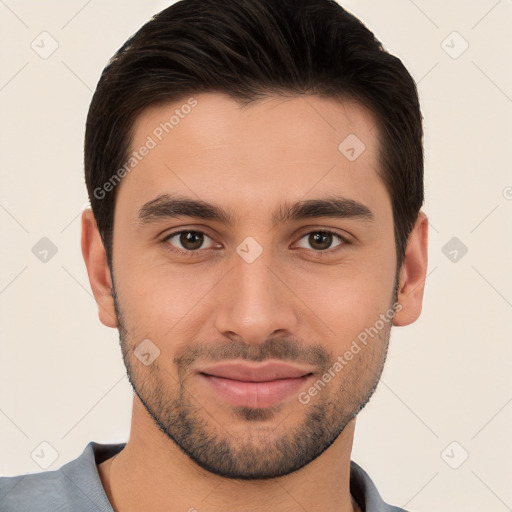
[393,212,428,326]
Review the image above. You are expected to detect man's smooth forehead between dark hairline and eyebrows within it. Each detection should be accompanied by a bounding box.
[116,93,383,222]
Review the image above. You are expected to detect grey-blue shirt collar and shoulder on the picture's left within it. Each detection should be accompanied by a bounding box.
[0,442,124,512]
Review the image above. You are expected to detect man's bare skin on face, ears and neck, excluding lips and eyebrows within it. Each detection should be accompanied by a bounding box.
[82,93,427,512]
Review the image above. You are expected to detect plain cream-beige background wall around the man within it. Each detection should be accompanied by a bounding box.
[0,0,512,512]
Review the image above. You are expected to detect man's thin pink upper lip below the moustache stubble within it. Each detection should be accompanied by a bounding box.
[199,361,313,382]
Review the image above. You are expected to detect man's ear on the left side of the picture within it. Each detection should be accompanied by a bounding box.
[81,208,117,327]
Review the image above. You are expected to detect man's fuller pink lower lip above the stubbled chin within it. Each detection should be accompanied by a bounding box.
[199,373,312,409]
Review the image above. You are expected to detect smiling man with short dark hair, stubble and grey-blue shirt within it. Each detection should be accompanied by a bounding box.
[0,0,427,512]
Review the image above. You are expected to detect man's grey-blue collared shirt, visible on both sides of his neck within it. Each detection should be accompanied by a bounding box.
[0,442,406,512]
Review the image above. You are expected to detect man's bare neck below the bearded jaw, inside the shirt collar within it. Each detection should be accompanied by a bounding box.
[98,401,359,512]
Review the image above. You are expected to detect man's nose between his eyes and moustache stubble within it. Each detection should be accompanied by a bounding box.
[215,251,298,344]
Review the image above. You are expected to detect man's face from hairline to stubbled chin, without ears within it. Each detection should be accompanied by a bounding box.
[112,94,396,479]
